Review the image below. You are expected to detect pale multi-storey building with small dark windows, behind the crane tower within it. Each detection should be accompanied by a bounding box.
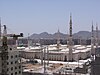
[0,46,22,75]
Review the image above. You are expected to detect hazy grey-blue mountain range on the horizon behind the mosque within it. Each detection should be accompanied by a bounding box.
[30,31,100,39]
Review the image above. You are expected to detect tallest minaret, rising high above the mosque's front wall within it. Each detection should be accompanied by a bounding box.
[68,14,73,61]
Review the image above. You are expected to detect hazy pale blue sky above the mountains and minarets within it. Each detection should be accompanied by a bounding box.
[0,0,100,36]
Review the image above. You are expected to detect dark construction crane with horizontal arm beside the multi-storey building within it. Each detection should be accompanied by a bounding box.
[1,25,23,75]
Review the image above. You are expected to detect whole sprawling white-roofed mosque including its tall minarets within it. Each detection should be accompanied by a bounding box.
[17,15,98,64]
